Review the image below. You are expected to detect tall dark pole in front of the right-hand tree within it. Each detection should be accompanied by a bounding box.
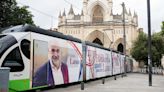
[147,0,152,86]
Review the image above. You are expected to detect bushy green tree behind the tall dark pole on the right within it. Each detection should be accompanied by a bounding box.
[131,29,164,66]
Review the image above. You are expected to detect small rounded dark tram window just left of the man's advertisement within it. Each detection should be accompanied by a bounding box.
[21,39,30,59]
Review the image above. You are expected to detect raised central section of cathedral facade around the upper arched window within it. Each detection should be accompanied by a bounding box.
[83,0,113,22]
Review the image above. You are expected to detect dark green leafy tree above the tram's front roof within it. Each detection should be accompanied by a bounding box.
[0,0,34,28]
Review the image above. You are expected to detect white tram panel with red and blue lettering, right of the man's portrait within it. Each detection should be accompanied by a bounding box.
[86,45,112,80]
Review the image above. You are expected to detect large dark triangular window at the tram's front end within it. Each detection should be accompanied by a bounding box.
[2,47,24,72]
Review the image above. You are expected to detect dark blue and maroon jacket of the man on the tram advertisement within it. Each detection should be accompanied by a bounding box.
[32,61,69,87]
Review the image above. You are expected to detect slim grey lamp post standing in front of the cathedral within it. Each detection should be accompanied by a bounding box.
[121,2,127,76]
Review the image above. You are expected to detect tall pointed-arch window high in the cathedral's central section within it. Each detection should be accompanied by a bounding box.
[92,5,103,23]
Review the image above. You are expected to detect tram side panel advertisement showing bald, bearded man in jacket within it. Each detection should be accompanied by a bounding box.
[31,33,82,88]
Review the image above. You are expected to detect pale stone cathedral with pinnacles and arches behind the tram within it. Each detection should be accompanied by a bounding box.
[58,0,142,54]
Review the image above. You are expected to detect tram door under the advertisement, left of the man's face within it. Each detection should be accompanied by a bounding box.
[32,40,48,87]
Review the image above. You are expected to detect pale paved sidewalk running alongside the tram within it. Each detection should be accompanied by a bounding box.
[43,73,164,92]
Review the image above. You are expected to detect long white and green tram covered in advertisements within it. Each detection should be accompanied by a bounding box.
[0,24,132,92]
